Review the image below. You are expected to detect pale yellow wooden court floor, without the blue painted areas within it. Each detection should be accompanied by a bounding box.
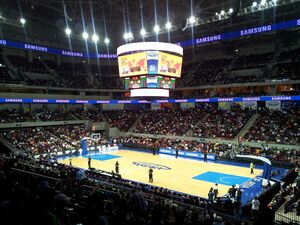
[59,150,262,198]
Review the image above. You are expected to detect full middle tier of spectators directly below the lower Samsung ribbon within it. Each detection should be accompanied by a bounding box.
[0,108,300,145]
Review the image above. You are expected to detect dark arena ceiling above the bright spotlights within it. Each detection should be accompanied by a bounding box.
[0,0,300,48]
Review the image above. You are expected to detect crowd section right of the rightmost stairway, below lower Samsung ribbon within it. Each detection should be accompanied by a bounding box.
[244,109,300,144]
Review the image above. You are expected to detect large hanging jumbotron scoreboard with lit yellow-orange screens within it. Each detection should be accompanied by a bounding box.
[117,42,183,97]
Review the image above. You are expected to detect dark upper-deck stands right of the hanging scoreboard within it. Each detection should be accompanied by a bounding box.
[178,49,300,87]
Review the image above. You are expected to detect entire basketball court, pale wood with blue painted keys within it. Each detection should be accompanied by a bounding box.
[59,150,263,198]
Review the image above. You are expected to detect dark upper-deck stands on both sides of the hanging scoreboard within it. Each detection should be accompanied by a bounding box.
[0,49,300,89]
